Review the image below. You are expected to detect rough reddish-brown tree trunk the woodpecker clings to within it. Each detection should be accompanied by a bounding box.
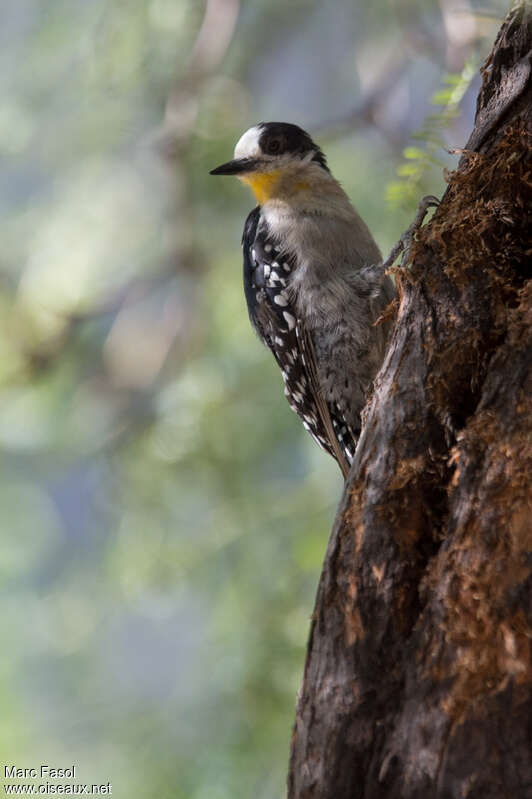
[288,3,532,799]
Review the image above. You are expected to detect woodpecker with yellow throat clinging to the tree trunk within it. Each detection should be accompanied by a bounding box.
[210,122,395,477]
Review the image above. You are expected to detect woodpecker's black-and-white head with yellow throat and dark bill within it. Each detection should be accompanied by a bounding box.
[210,122,329,205]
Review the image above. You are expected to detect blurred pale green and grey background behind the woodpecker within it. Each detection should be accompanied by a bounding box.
[0,0,505,799]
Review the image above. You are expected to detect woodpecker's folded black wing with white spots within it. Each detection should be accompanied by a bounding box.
[242,208,355,476]
